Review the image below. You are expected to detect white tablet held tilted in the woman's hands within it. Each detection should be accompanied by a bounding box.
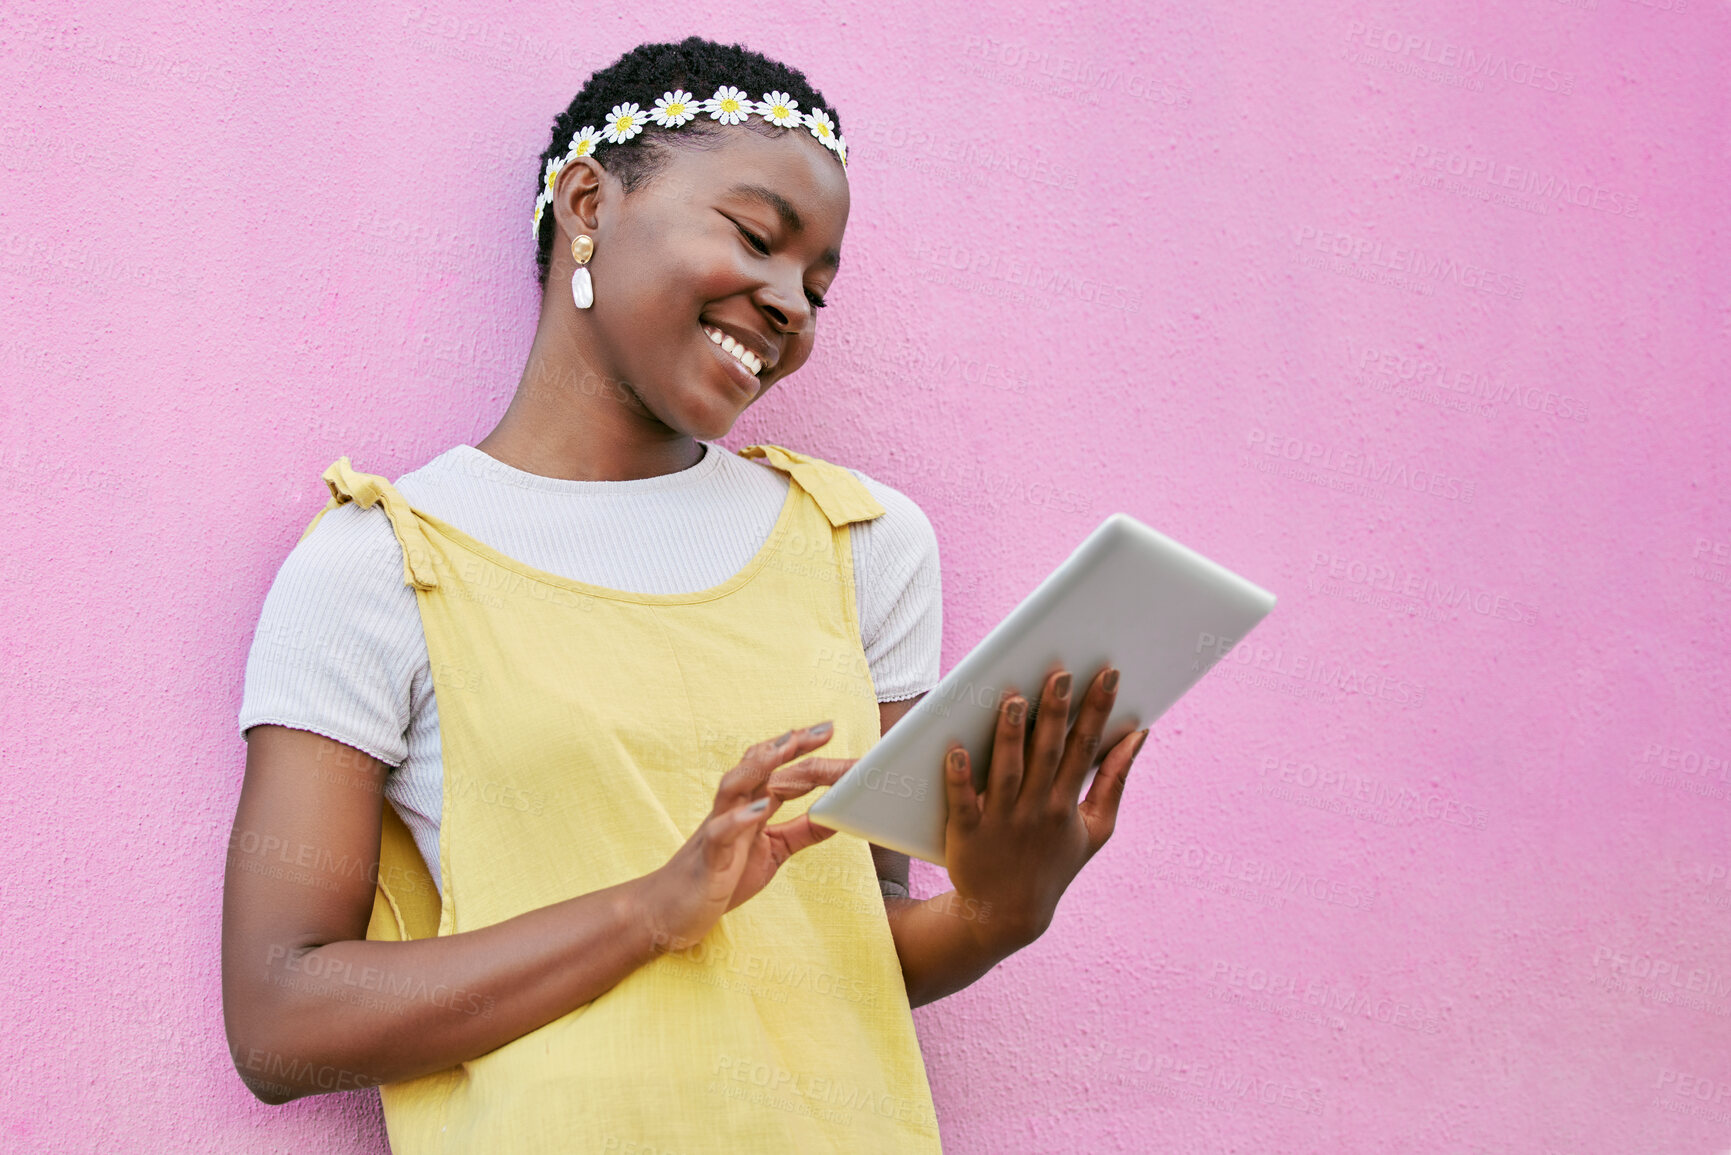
[810,513,1274,866]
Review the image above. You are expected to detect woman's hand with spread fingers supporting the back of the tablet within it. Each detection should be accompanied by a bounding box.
[943,667,1148,945]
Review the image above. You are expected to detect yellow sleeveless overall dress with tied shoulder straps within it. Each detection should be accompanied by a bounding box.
[308,445,940,1155]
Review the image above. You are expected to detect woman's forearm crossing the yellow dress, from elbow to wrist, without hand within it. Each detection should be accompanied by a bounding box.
[223,876,666,1103]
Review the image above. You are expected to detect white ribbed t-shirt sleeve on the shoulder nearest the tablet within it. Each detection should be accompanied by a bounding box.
[852,469,943,701]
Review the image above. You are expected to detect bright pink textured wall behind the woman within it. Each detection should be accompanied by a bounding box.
[0,0,1731,1155]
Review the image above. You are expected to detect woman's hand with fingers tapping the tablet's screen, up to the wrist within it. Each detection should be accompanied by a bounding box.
[644,722,859,954]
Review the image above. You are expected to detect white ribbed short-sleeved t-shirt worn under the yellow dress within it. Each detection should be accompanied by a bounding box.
[241,443,943,885]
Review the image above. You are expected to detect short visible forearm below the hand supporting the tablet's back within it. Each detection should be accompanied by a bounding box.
[885,890,1044,1006]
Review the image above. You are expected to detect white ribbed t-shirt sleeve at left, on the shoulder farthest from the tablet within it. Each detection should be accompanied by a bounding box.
[241,504,422,767]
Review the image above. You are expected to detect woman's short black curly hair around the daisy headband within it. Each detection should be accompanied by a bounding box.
[535,36,841,289]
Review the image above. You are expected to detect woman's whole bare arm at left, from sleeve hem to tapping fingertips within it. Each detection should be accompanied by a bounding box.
[222,724,853,1103]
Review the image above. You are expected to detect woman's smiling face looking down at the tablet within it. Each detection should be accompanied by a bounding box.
[544,128,848,440]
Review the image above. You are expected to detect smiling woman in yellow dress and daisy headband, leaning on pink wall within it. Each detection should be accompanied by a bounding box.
[223,38,1146,1152]
